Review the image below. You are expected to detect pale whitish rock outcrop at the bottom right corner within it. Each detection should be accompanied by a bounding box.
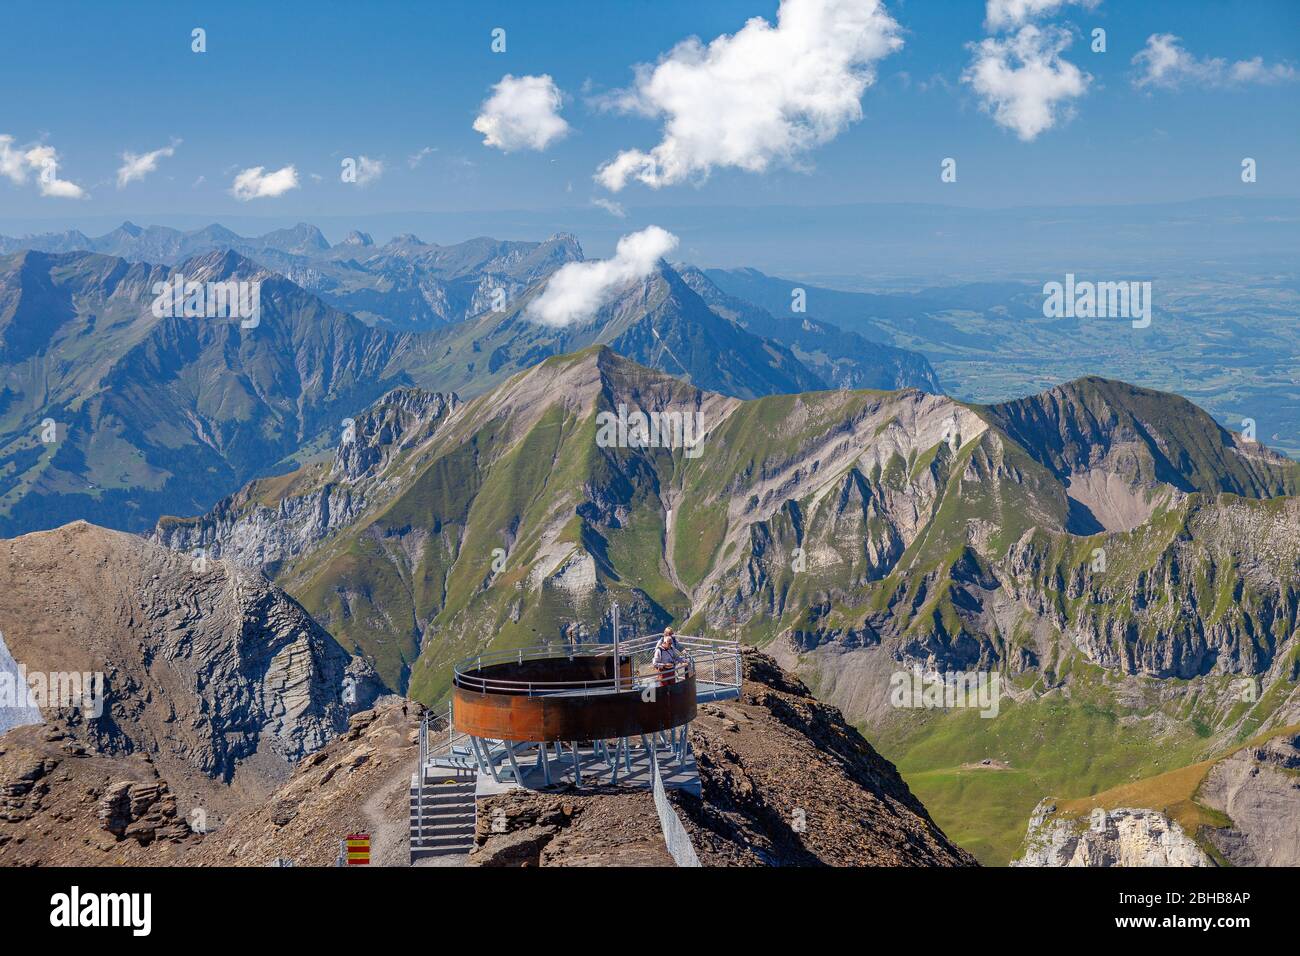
[1011,800,1214,866]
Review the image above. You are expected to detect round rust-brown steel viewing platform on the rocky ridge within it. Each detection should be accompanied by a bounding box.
[451,639,697,743]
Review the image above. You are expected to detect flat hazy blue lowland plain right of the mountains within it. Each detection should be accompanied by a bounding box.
[706,264,1300,457]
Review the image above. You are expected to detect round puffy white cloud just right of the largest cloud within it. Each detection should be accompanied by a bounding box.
[962,25,1092,142]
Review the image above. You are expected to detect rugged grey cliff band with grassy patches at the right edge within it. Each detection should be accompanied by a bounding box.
[1002,494,1300,682]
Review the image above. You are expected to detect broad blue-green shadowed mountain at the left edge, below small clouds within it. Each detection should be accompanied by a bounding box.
[0,252,439,536]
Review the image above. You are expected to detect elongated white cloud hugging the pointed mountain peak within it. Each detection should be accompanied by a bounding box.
[525,226,677,326]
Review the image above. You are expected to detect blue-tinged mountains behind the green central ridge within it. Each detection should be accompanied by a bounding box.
[0,225,939,533]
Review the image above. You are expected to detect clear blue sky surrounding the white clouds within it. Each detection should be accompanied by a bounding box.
[0,0,1300,239]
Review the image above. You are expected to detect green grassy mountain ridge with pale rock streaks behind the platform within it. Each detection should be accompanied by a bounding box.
[156,347,1300,862]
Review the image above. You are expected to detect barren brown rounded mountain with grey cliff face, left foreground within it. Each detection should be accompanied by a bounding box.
[0,523,384,858]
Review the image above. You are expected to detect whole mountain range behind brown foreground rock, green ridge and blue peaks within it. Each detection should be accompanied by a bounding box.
[0,221,1300,865]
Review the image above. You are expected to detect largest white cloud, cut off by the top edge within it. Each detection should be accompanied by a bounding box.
[595,0,902,191]
